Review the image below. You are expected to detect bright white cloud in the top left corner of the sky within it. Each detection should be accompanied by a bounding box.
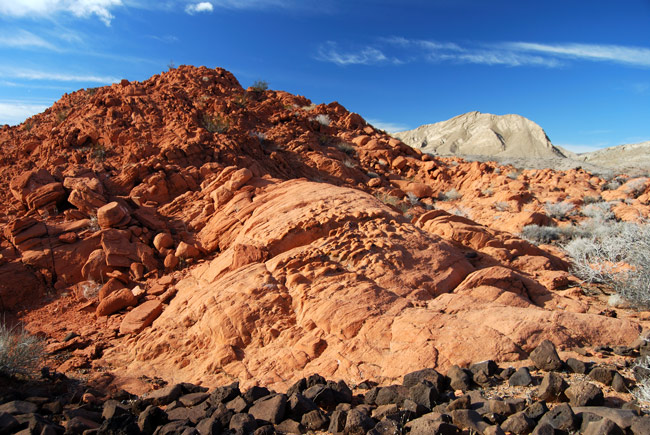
[0,0,123,26]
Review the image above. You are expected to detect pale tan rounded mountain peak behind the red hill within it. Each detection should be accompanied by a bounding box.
[394,112,566,157]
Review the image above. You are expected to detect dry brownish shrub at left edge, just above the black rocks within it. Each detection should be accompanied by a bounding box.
[0,323,45,376]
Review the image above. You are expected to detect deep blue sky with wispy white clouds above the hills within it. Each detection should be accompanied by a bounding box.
[0,0,650,151]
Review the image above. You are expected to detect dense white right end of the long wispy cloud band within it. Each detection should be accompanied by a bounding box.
[504,42,650,67]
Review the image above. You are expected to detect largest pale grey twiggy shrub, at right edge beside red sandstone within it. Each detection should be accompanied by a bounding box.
[564,222,650,307]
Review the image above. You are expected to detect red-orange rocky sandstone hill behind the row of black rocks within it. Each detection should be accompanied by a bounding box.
[0,66,650,396]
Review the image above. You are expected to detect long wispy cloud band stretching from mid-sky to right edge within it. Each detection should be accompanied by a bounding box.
[317,36,650,68]
